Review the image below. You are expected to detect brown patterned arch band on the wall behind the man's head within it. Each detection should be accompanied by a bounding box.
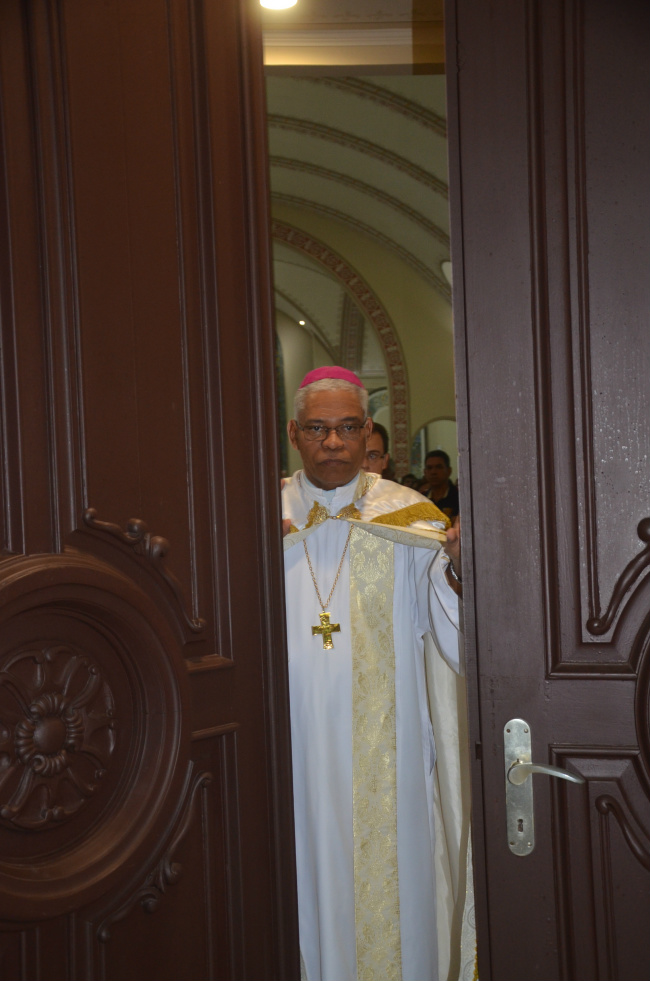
[271,220,410,477]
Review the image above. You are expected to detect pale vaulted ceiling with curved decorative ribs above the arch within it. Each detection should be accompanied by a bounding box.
[267,75,450,300]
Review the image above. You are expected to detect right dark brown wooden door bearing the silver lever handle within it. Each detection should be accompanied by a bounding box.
[447,0,650,981]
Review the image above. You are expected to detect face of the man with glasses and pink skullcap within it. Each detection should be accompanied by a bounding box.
[287,389,372,490]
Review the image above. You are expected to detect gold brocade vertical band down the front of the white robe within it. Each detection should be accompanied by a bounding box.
[350,528,402,981]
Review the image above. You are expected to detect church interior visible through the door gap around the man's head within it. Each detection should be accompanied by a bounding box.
[263,0,450,479]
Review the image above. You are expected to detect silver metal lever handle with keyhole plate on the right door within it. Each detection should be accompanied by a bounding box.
[503,719,585,857]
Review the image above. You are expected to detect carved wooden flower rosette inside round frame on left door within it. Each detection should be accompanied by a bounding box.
[0,647,115,831]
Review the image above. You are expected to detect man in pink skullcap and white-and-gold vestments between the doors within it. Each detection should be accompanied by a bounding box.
[283,368,459,981]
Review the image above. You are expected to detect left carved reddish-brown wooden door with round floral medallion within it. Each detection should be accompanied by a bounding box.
[0,0,298,981]
